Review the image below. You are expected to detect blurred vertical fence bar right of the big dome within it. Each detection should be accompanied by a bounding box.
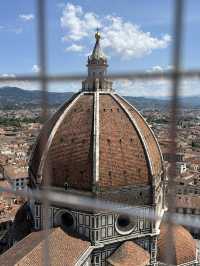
[165,0,184,265]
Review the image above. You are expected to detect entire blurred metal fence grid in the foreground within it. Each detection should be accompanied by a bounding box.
[0,0,200,265]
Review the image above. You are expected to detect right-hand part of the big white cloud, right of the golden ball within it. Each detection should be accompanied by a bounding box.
[102,16,171,59]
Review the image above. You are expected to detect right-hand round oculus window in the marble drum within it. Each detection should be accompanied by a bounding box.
[115,214,136,235]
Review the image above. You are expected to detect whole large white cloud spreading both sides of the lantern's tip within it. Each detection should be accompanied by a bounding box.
[60,3,171,59]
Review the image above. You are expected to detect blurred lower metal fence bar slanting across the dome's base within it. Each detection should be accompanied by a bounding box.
[0,187,200,231]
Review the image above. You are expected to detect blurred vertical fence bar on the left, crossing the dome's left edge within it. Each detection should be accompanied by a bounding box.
[37,0,51,266]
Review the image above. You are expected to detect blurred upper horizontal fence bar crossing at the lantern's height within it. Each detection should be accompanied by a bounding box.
[0,69,200,83]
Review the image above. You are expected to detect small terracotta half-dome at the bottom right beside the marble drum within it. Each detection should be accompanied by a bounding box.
[158,225,196,265]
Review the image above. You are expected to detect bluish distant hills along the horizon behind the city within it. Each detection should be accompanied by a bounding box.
[0,87,200,109]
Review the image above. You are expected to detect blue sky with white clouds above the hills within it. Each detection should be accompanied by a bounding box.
[0,0,200,96]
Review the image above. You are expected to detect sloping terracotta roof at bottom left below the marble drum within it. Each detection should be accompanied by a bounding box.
[0,228,91,266]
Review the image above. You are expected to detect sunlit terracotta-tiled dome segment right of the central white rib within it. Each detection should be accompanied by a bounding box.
[99,95,150,189]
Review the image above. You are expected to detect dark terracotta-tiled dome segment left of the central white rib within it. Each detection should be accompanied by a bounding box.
[43,92,93,190]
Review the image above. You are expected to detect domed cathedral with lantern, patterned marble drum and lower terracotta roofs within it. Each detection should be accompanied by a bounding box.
[0,32,197,266]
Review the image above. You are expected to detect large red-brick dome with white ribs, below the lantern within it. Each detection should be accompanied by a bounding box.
[29,91,163,191]
